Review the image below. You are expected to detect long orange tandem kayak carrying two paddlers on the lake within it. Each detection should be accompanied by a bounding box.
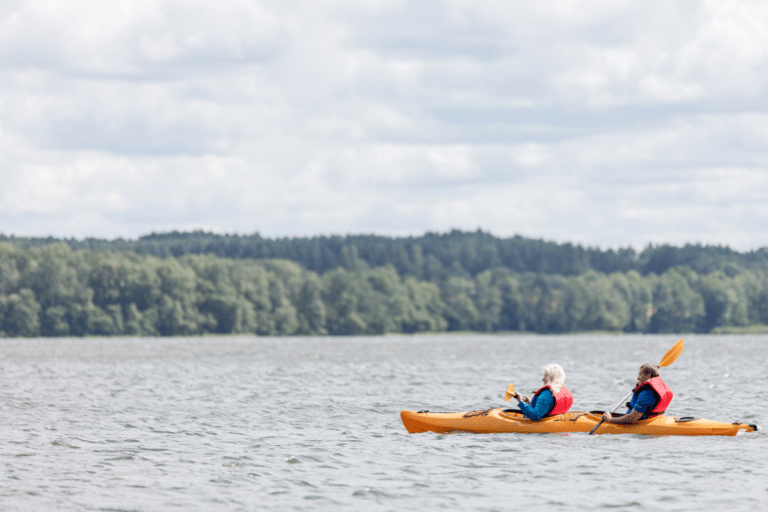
[400,409,758,436]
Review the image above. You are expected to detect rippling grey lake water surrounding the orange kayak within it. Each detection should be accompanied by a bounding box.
[0,335,768,511]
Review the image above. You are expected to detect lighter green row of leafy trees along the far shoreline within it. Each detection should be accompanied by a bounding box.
[0,242,768,337]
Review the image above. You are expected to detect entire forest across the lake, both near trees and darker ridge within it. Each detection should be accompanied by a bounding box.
[0,231,768,337]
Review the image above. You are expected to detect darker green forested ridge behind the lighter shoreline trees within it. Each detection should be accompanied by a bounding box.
[0,230,768,285]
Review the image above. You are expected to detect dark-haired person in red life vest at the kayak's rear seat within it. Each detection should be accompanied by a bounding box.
[603,363,672,424]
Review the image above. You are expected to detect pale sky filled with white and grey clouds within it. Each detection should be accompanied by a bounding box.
[0,0,768,251]
